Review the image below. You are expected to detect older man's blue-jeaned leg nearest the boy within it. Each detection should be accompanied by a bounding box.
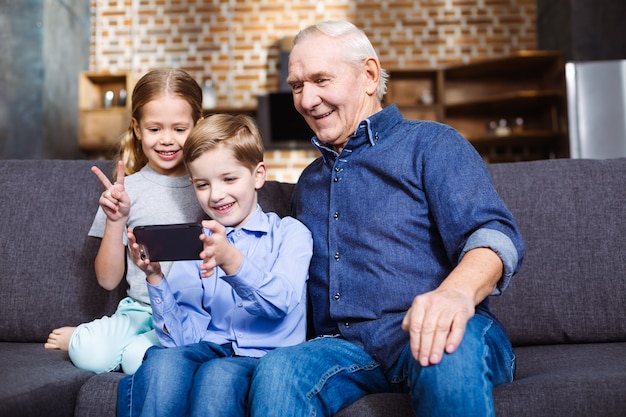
[249,337,391,417]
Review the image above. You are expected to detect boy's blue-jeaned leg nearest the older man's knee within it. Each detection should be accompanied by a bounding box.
[189,356,259,417]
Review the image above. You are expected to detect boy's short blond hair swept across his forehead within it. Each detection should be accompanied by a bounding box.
[183,114,264,172]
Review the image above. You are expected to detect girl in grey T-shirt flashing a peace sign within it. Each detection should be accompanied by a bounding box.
[45,69,204,374]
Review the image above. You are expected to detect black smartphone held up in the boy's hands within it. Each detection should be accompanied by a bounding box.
[133,223,204,262]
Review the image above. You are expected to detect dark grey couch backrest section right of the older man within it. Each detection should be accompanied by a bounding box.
[489,159,626,345]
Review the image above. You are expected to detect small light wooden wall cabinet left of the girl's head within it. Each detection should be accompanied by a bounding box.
[78,71,135,155]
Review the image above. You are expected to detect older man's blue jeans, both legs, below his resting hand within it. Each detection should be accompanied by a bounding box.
[250,314,515,417]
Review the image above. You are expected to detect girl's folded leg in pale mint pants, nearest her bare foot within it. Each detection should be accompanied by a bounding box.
[68,298,152,373]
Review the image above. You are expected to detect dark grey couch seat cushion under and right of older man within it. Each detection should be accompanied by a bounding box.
[337,343,626,417]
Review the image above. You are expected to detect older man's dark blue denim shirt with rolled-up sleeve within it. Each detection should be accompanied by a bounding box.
[293,106,524,369]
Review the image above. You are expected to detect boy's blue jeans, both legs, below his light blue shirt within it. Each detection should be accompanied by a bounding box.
[117,342,259,417]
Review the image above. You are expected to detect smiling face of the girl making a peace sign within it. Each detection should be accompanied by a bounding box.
[132,94,194,177]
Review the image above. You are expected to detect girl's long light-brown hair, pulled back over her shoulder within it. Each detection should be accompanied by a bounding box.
[118,68,202,175]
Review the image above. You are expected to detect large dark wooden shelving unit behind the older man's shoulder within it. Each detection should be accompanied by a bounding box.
[386,51,569,162]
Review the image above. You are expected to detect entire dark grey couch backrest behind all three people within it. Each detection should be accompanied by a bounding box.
[0,159,626,345]
